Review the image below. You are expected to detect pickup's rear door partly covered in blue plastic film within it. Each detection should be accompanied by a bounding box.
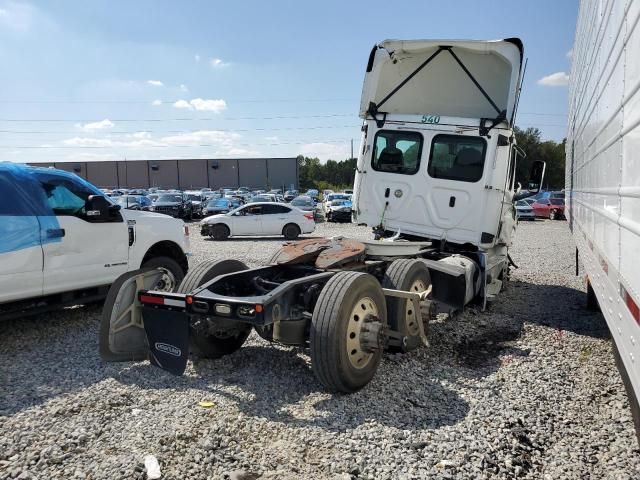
[0,168,46,303]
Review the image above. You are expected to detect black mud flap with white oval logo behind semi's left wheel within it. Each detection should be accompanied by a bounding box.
[142,308,189,375]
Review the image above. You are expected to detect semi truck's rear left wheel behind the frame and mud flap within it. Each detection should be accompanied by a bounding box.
[178,260,251,358]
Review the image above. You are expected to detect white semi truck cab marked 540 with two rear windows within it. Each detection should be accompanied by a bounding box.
[353,38,544,302]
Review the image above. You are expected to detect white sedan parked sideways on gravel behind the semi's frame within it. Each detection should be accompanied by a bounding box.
[200,202,316,240]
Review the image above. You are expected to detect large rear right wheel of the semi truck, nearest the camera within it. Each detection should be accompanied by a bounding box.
[309,272,387,393]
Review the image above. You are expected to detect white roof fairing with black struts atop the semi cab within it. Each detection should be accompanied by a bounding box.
[360,38,522,123]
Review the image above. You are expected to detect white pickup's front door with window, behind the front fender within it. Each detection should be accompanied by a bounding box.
[37,172,129,295]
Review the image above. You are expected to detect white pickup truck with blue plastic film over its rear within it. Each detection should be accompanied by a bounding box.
[0,163,189,319]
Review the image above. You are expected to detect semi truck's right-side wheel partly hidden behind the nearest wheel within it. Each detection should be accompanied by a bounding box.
[382,258,431,352]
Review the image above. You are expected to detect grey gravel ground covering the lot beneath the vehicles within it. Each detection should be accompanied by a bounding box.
[0,221,640,480]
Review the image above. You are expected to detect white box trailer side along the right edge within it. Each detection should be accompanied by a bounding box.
[566,0,640,432]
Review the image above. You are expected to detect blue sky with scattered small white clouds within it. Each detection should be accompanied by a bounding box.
[0,0,578,162]
